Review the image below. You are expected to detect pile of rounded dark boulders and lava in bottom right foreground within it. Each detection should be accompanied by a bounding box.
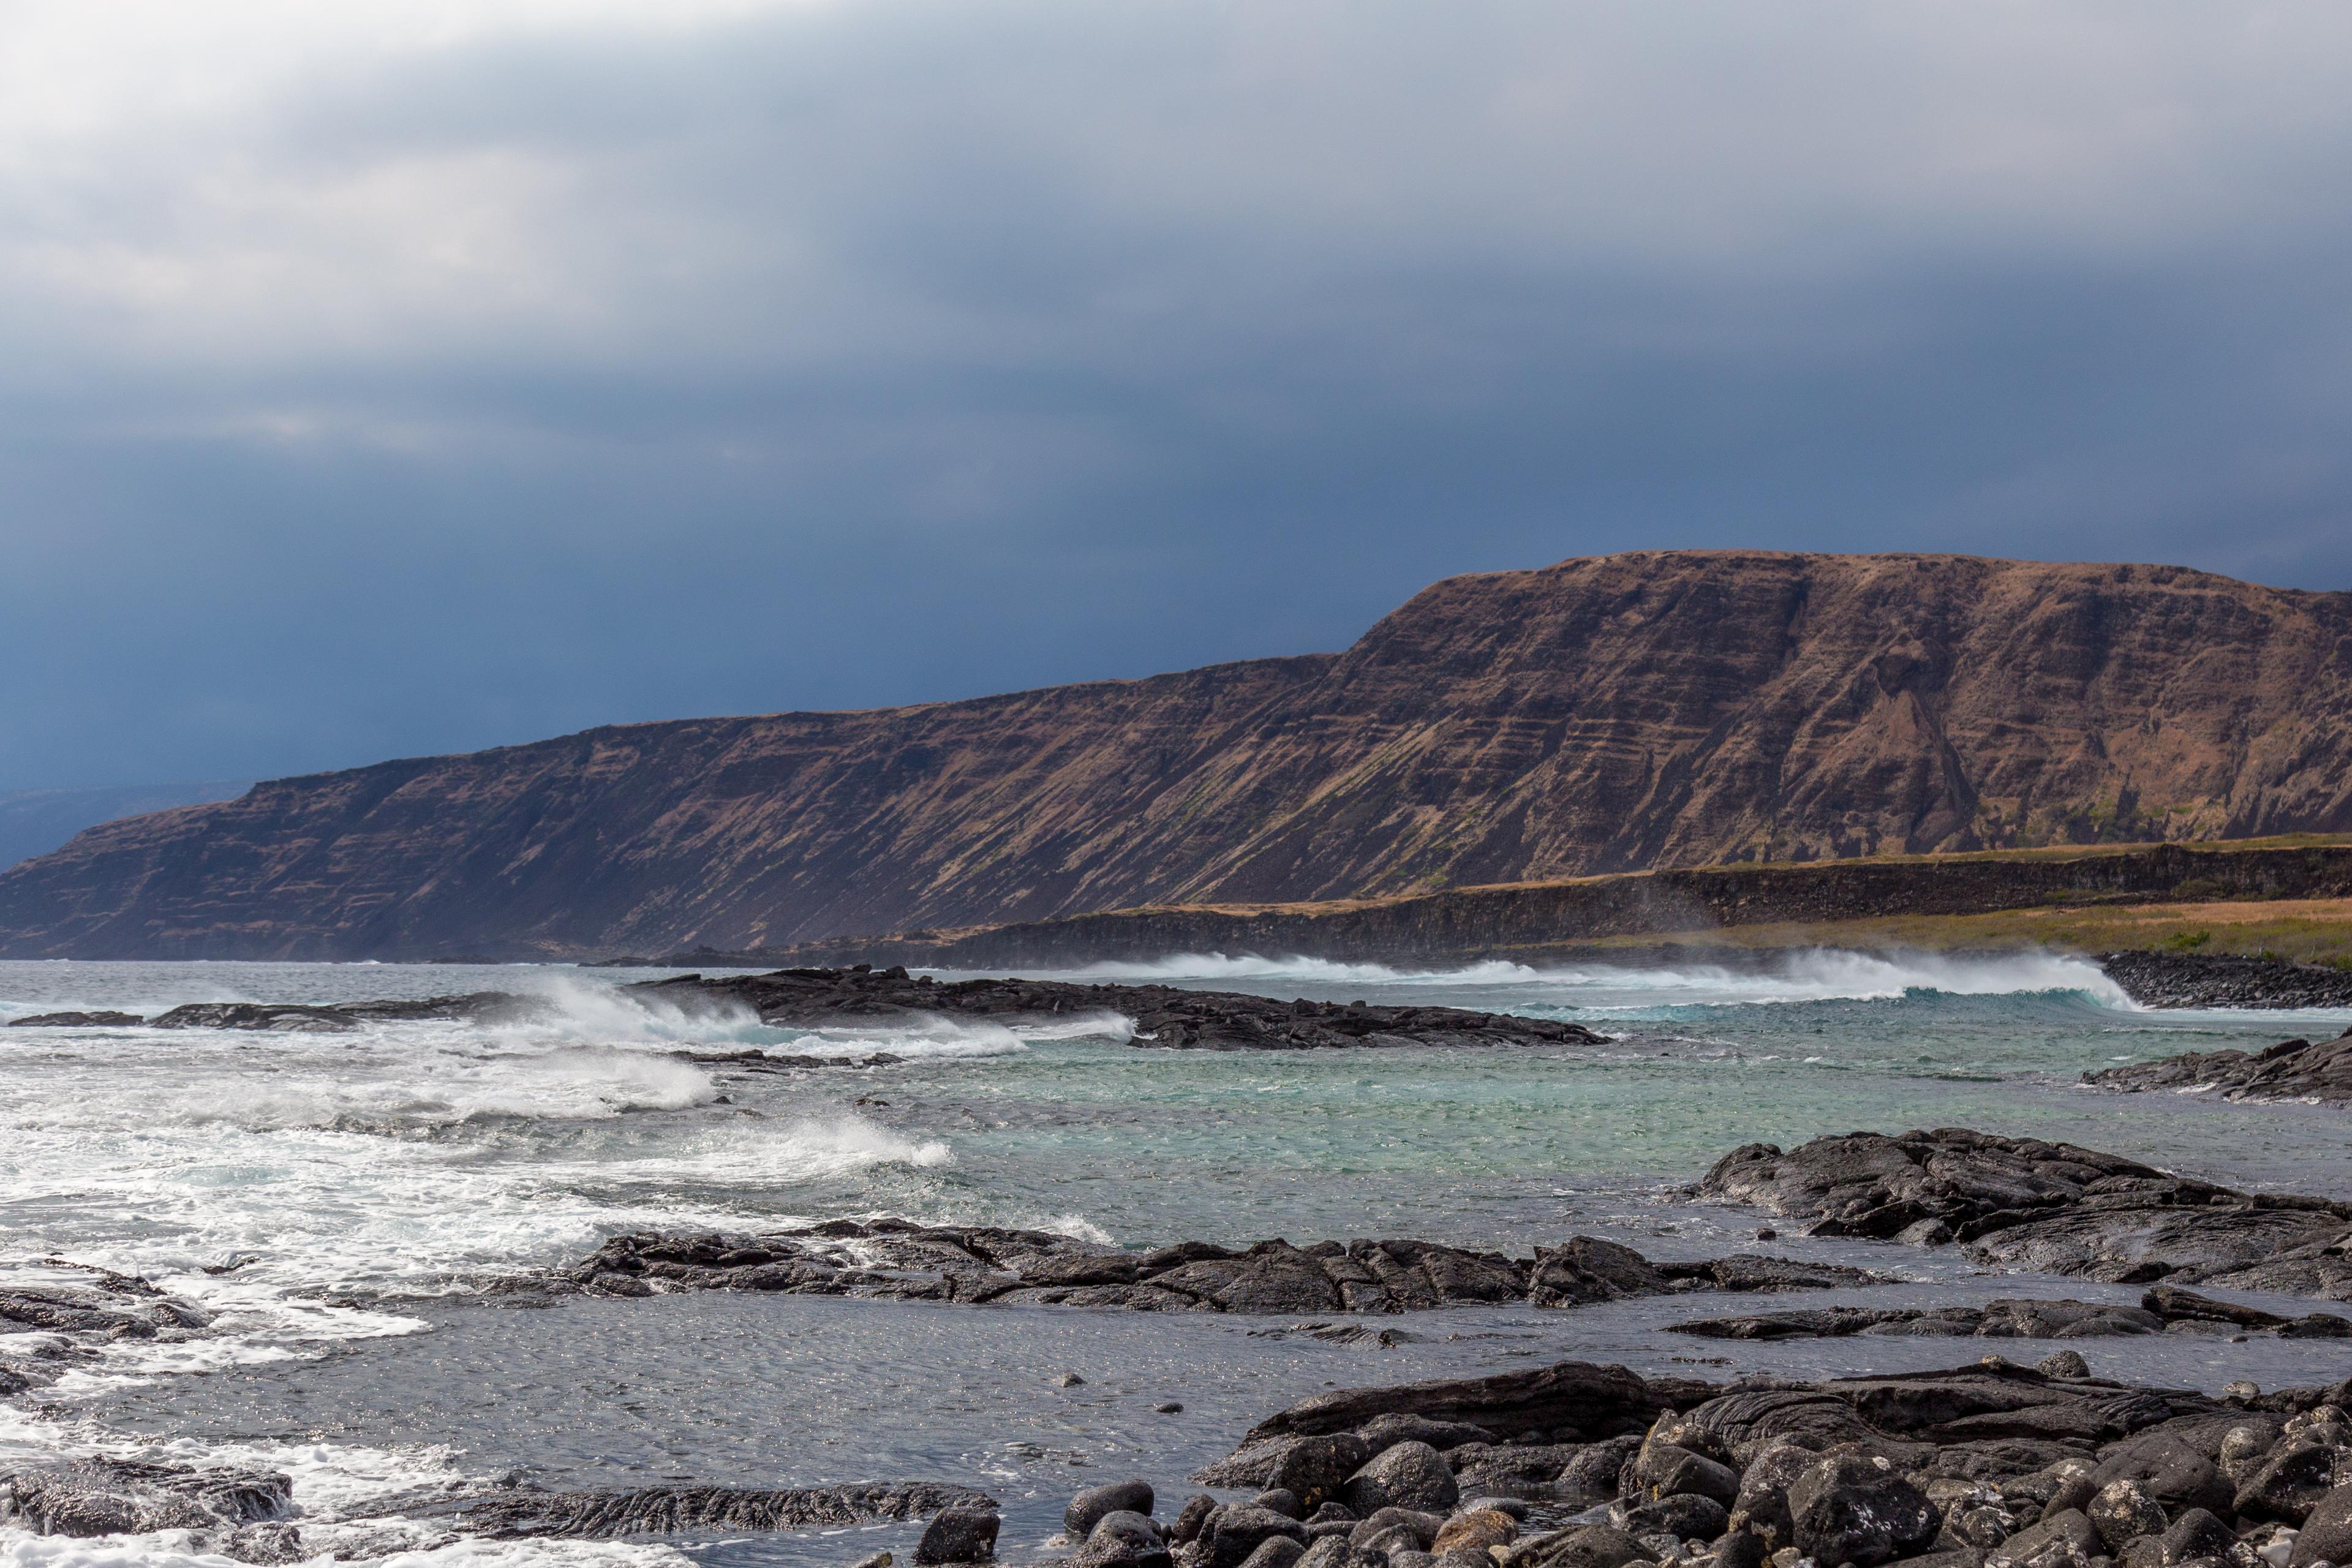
[1176,1357,2352,1568]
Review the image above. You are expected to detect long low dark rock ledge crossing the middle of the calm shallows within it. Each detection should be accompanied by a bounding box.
[545,1220,1874,1314]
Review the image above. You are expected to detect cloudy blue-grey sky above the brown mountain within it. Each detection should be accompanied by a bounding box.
[0,0,2352,790]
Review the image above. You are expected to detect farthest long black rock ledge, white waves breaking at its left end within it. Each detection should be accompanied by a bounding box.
[625,964,1602,1051]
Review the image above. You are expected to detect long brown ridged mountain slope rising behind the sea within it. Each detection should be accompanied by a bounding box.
[0,552,2352,959]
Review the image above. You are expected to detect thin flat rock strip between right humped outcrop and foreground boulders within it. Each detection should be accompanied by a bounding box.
[1670,1286,2352,1340]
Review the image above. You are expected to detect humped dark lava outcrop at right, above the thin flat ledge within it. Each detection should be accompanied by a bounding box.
[1698,1128,2352,1300]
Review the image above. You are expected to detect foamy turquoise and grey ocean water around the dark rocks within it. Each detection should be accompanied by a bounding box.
[0,952,2352,1568]
